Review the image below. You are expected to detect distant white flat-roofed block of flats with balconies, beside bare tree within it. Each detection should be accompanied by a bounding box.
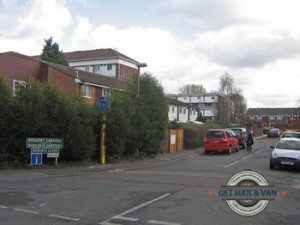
[166,93,224,121]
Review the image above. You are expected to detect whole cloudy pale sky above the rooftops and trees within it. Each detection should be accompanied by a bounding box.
[0,0,300,108]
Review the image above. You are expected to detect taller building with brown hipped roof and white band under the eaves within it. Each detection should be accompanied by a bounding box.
[63,48,145,82]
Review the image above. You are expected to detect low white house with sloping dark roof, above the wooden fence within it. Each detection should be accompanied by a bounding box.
[167,98,198,123]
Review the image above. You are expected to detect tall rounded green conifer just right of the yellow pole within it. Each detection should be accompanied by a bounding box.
[126,74,168,155]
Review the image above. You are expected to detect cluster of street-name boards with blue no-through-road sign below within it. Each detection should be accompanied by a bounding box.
[26,137,64,166]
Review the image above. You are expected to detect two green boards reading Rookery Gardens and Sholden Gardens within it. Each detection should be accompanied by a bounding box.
[26,138,64,149]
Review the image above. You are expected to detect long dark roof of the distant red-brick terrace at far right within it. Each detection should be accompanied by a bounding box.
[247,108,300,115]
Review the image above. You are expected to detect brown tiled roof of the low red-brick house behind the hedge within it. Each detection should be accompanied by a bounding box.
[43,61,126,90]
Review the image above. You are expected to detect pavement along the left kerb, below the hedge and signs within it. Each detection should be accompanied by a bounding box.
[0,135,266,180]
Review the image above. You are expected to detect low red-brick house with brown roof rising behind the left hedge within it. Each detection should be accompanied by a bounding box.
[0,52,126,104]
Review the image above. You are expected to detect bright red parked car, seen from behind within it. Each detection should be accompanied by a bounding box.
[203,129,239,155]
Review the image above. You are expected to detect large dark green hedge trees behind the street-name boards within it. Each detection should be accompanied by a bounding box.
[0,79,97,165]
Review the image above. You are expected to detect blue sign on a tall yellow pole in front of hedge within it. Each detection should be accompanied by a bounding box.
[99,96,107,164]
